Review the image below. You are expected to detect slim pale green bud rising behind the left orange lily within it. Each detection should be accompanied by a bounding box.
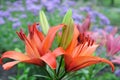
[40,11,49,35]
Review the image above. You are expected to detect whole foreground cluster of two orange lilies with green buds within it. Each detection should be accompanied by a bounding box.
[0,10,114,80]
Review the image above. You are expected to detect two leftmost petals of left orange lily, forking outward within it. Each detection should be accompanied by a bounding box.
[1,51,43,70]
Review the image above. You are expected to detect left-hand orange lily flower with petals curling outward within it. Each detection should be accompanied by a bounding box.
[1,24,64,70]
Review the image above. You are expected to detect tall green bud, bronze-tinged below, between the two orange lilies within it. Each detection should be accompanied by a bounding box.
[60,10,74,49]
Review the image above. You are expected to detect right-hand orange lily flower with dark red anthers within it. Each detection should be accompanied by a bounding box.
[64,26,114,72]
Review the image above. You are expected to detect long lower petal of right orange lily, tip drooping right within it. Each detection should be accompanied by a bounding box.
[67,56,114,71]
